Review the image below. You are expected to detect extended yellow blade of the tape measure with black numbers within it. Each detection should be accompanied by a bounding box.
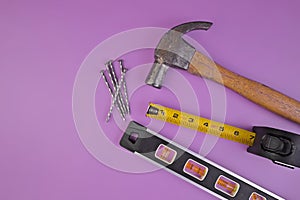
[146,103,256,146]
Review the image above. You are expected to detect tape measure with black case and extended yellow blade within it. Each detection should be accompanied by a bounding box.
[146,103,300,168]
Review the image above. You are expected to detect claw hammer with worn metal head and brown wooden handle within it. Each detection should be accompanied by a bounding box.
[146,21,300,124]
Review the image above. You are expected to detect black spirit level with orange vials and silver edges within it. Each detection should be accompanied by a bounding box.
[120,121,283,200]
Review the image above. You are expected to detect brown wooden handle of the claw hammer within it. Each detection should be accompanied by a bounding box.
[188,51,300,124]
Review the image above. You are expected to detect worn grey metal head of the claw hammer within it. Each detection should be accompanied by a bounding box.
[145,21,212,88]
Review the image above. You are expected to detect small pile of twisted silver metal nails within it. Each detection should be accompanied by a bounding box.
[100,60,130,122]
